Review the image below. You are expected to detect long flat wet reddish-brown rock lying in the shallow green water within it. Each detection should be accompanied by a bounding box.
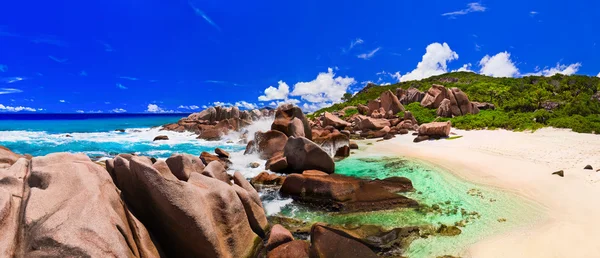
[280,173,417,212]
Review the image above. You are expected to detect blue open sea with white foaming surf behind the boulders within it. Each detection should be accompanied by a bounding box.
[0,114,245,158]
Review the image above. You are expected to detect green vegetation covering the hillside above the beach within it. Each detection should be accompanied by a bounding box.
[314,72,600,134]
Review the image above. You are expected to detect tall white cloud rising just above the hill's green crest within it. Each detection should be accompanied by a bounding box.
[400,42,458,82]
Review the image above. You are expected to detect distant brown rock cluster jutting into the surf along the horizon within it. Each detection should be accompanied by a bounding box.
[162,106,274,140]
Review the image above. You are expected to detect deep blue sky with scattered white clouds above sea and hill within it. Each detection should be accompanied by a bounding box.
[0,0,600,113]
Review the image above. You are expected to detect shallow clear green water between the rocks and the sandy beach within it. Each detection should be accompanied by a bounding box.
[280,155,541,257]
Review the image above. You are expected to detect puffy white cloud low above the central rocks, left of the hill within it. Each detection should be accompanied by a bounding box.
[290,68,356,103]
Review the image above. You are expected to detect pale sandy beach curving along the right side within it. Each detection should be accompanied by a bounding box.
[367,128,600,258]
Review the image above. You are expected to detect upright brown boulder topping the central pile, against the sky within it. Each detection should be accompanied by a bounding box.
[271,104,312,139]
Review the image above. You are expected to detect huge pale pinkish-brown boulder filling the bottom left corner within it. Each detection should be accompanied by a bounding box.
[0,153,159,257]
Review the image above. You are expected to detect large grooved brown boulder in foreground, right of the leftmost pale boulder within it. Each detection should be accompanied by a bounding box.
[114,156,259,257]
